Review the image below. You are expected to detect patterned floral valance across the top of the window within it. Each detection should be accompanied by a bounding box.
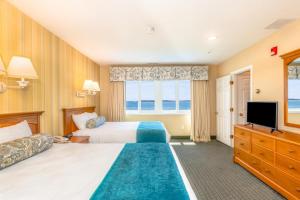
[110,66,208,81]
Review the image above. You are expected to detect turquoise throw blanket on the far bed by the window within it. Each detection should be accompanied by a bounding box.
[136,122,166,143]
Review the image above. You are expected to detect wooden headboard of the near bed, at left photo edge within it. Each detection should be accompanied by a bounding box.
[0,111,44,134]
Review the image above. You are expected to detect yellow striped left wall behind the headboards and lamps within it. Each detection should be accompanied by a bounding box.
[0,0,100,135]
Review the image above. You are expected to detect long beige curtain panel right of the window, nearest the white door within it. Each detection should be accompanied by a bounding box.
[191,81,210,142]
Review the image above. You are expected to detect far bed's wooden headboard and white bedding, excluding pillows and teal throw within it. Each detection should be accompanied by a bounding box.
[63,107,171,143]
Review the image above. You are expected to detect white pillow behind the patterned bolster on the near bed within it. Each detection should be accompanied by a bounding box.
[0,120,32,143]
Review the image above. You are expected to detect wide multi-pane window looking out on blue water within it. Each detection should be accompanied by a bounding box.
[125,80,191,113]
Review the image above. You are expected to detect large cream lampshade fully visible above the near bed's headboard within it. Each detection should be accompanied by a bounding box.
[7,56,38,79]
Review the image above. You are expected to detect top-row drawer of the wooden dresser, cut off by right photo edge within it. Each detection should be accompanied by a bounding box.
[276,140,300,161]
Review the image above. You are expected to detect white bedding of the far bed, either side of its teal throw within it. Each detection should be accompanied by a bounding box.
[73,122,170,143]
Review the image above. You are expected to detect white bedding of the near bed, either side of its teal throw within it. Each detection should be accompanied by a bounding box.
[0,143,197,200]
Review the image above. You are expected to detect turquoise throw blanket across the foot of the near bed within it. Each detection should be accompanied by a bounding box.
[90,143,189,200]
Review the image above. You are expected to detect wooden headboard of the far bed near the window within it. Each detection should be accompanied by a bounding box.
[63,106,95,135]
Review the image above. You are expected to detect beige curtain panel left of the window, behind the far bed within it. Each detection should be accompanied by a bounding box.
[107,81,125,121]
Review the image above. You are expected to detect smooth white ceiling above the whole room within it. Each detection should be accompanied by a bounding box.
[9,0,300,64]
